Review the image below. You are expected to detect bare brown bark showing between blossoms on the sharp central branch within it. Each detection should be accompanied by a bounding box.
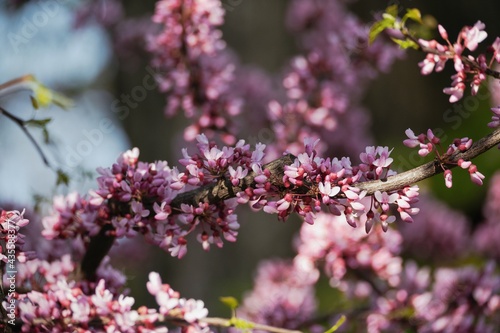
[81,129,500,278]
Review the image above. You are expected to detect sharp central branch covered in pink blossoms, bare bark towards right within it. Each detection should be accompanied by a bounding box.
[76,123,500,277]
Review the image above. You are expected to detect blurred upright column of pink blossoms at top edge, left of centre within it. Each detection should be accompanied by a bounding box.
[149,0,241,143]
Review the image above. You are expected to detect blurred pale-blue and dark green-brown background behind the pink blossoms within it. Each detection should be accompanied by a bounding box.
[0,0,500,316]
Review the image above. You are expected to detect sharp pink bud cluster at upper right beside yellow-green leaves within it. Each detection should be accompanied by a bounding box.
[418,21,500,103]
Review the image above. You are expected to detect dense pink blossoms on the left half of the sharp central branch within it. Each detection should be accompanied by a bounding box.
[42,135,267,257]
